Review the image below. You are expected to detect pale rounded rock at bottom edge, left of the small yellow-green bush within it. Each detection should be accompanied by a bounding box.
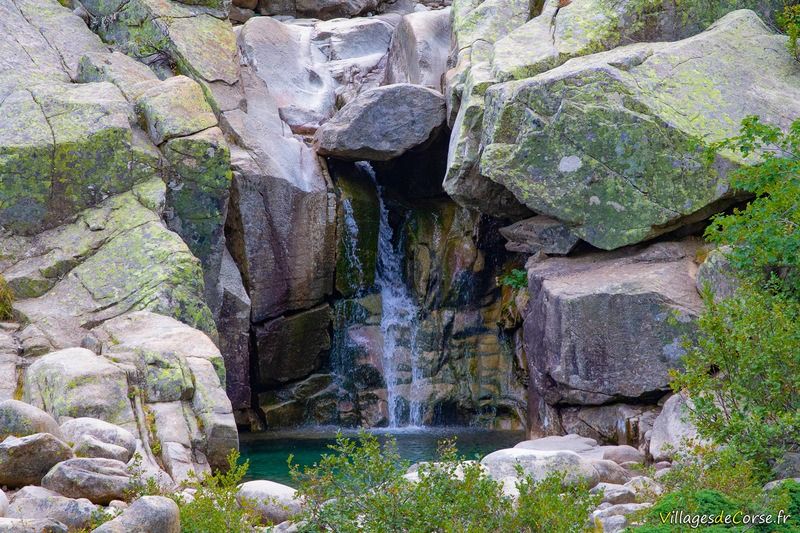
[93,496,181,533]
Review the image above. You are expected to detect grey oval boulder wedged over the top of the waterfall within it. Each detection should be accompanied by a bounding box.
[314,83,445,161]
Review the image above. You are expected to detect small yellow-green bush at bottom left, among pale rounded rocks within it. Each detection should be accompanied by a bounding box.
[173,450,260,533]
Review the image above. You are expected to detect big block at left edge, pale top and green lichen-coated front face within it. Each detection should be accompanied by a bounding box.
[0,83,152,233]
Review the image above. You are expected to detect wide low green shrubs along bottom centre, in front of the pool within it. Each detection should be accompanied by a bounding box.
[289,433,599,533]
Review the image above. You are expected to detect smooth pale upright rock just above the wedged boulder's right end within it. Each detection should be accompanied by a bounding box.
[384,8,450,92]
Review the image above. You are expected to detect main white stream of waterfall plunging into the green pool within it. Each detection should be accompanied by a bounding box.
[357,161,423,427]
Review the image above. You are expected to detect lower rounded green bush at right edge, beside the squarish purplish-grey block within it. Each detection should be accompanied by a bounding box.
[673,285,800,464]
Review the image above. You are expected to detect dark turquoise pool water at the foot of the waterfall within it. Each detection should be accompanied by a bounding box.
[240,428,525,485]
